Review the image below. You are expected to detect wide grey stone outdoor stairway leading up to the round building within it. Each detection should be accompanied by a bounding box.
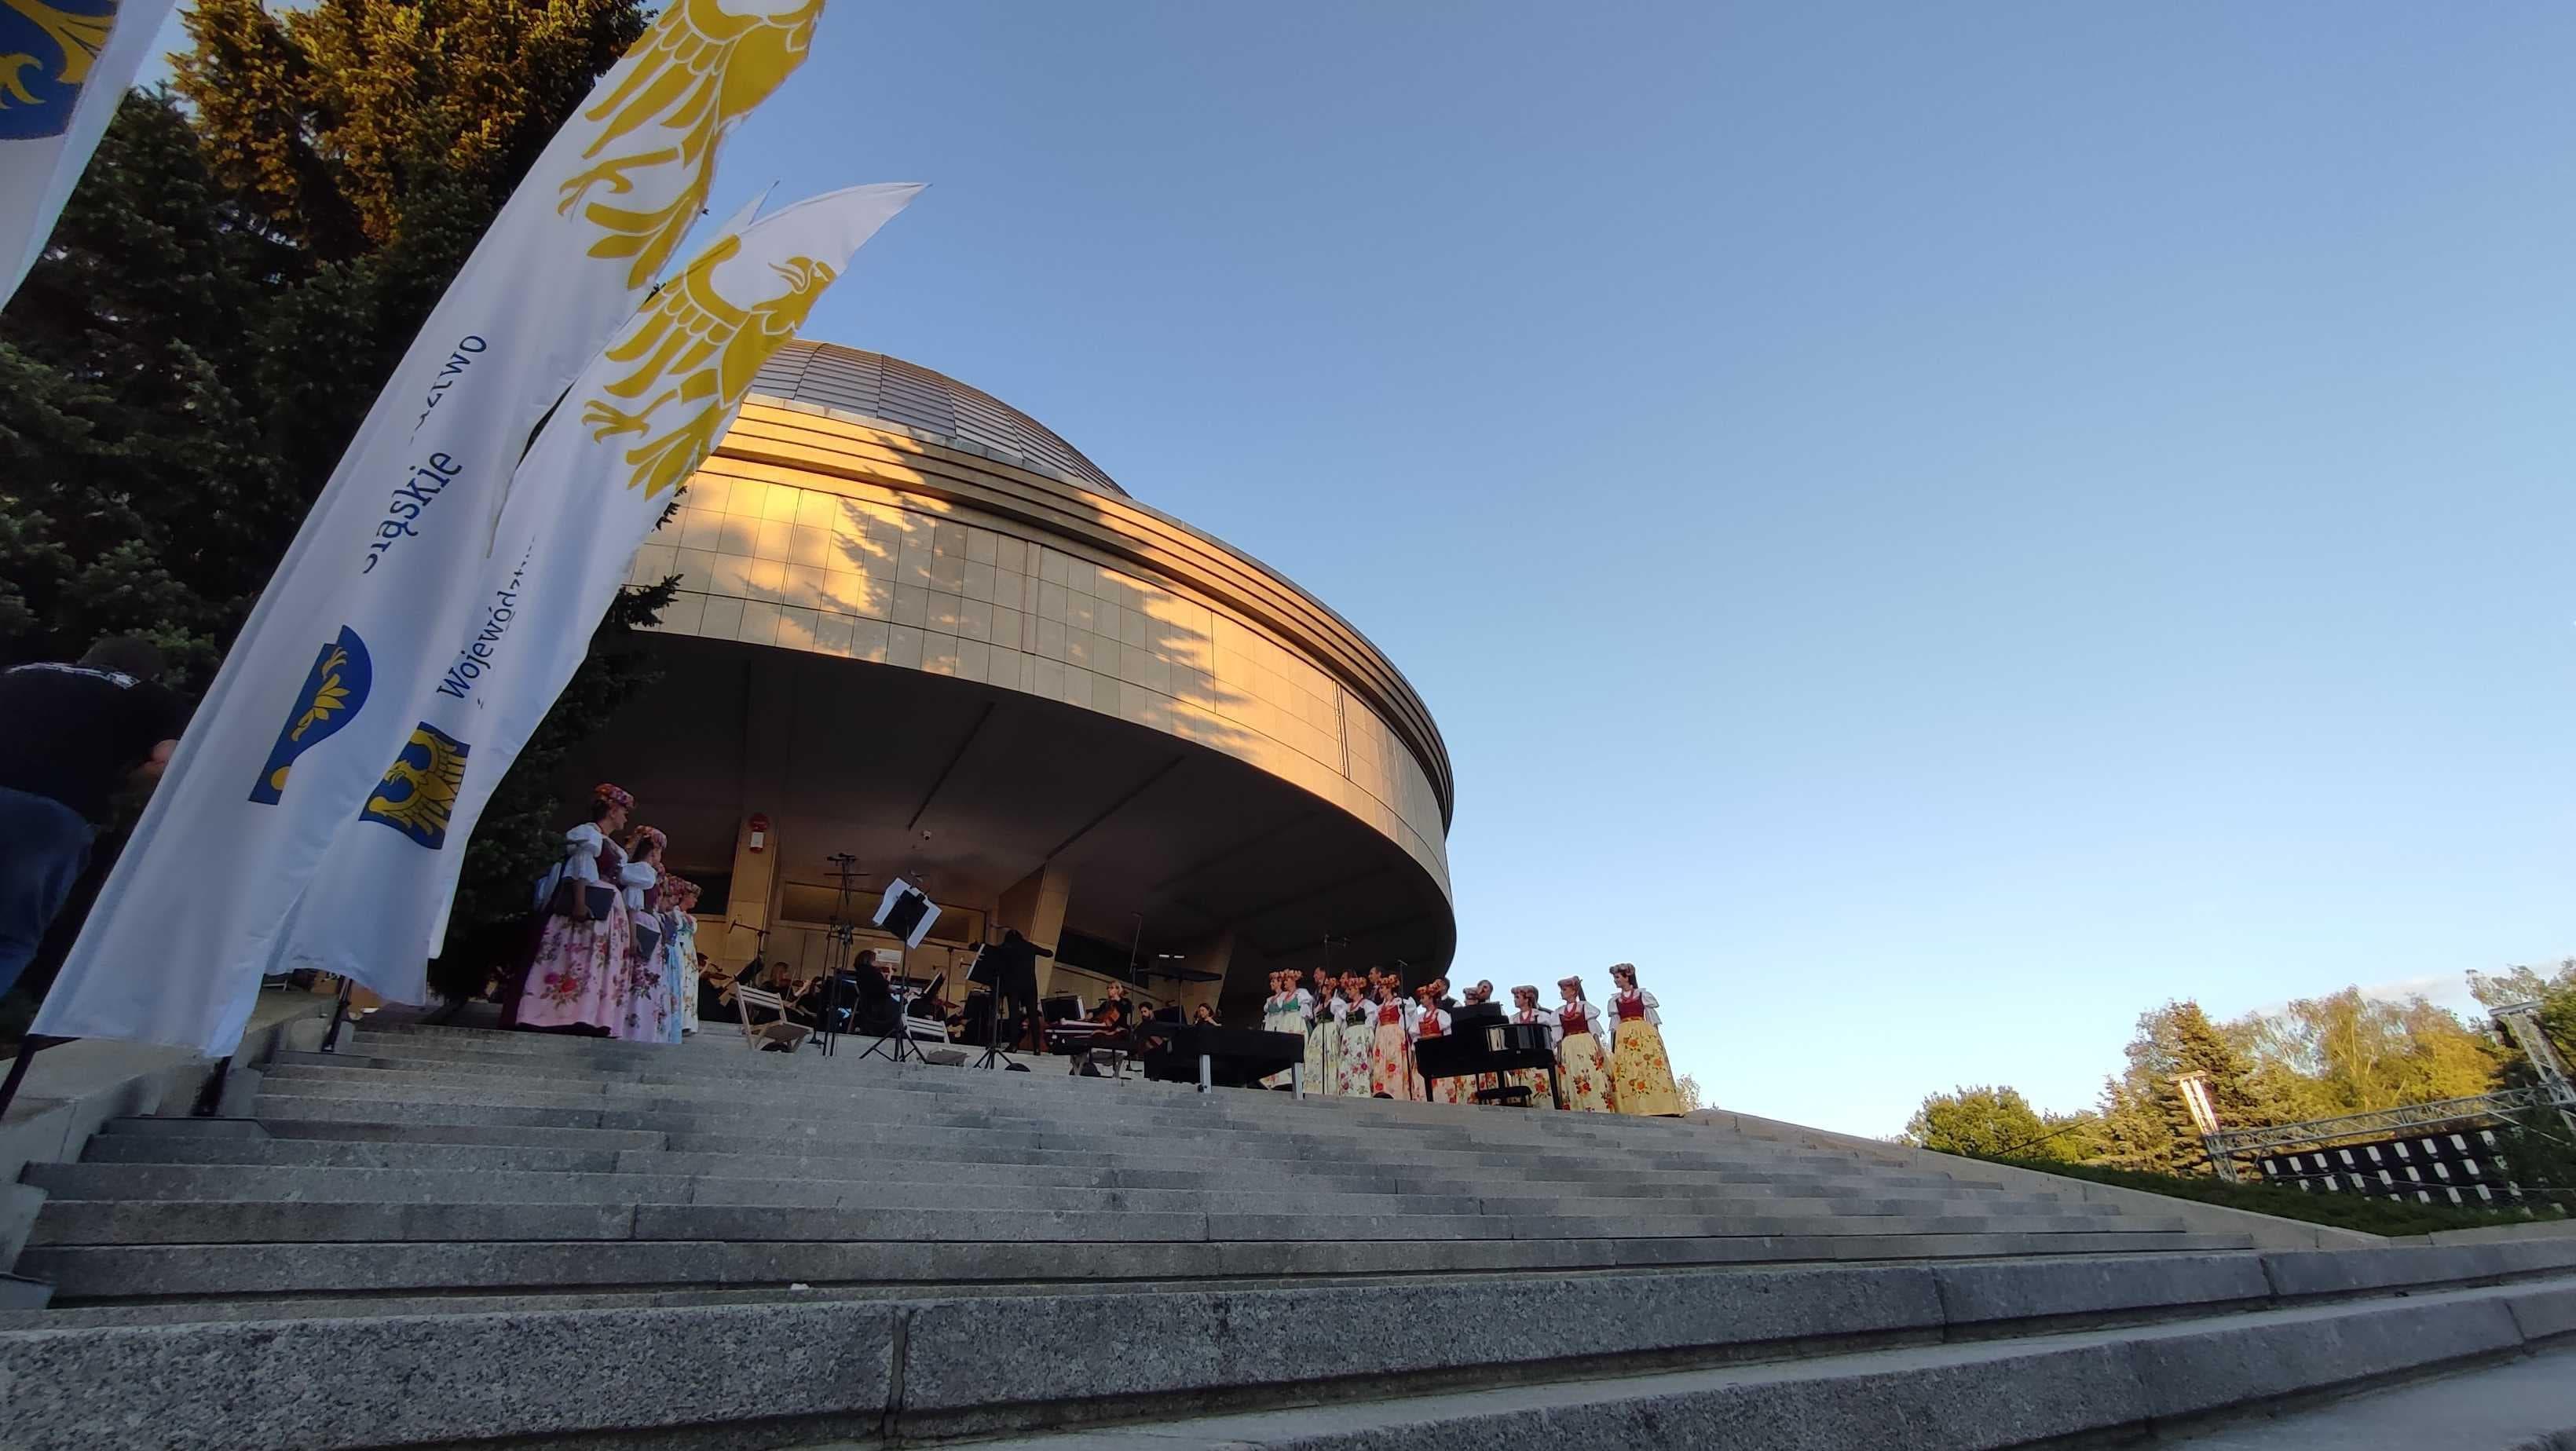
[0,1023,2576,1451]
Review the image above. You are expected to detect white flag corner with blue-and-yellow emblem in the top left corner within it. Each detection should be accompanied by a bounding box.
[0,0,173,304]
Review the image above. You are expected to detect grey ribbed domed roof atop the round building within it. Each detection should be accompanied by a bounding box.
[752,338,1125,498]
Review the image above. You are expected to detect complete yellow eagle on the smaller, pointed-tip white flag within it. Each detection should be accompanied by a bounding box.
[582,235,837,498]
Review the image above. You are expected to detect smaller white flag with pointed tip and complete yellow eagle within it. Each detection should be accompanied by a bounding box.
[286,183,920,1003]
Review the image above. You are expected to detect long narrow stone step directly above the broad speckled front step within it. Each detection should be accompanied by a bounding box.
[5,1212,2246,1304]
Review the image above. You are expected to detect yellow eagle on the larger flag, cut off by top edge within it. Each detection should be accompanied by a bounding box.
[554,0,821,286]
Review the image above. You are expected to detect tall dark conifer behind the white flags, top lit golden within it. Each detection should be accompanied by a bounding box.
[0,0,668,1020]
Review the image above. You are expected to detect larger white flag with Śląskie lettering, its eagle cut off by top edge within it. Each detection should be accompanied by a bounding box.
[37,0,821,1054]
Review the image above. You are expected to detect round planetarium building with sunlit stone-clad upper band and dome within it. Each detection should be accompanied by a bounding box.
[584,343,1455,1015]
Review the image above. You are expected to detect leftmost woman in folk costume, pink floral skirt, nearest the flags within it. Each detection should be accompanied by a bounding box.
[515,784,636,1036]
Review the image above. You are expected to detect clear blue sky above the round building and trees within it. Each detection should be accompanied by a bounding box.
[196,0,2576,1134]
